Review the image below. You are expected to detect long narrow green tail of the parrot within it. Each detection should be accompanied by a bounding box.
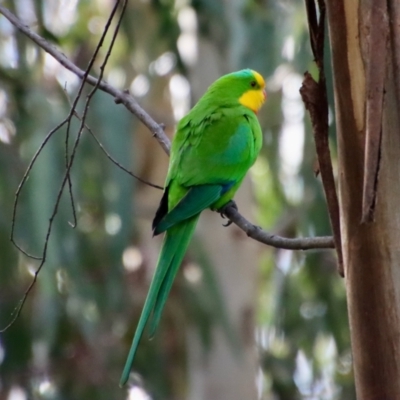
[120,214,200,387]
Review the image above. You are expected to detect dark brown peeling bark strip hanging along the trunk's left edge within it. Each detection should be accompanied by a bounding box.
[300,0,344,276]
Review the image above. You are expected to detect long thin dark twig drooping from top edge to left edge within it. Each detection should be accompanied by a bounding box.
[0,0,127,332]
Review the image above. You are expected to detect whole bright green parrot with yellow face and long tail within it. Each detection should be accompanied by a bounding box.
[120,69,266,386]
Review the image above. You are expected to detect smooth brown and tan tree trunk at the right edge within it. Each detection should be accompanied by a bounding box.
[327,0,400,400]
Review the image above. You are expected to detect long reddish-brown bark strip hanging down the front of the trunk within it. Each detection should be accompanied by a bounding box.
[361,0,389,223]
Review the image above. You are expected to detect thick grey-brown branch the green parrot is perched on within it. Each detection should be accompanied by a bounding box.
[0,5,334,250]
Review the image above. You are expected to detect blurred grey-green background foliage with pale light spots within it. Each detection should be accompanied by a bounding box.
[0,0,355,400]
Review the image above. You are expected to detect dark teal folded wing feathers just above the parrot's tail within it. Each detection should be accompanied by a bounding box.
[153,185,223,235]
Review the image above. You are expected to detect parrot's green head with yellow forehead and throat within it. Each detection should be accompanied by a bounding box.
[209,69,267,113]
